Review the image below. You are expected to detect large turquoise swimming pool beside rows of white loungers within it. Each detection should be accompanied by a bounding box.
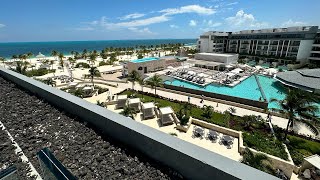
[164,75,320,115]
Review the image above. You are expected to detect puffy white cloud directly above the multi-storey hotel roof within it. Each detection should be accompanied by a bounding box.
[225,10,268,28]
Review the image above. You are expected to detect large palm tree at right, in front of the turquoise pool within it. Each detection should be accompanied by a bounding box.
[270,88,319,140]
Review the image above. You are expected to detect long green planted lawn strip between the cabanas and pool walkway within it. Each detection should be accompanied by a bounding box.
[122,91,288,160]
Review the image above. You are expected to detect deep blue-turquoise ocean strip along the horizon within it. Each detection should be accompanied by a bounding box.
[0,39,196,58]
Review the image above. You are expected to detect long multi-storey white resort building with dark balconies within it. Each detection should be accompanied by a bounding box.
[197,26,320,63]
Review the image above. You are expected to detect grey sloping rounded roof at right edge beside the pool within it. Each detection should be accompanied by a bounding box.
[276,69,320,94]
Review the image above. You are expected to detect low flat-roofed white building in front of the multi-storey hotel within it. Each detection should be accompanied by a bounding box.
[194,53,239,64]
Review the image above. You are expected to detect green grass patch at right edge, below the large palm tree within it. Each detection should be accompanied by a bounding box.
[288,135,320,165]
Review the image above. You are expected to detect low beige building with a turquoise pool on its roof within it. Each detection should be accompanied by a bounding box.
[123,56,186,76]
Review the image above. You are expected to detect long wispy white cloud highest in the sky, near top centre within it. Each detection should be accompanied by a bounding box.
[159,5,215,15]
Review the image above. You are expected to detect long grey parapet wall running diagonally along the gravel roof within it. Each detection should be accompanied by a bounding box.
[0,68,277,180]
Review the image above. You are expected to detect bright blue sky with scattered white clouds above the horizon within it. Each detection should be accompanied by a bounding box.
[0,0,320,42]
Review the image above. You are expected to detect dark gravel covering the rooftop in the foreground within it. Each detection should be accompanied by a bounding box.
[0,77,182,179]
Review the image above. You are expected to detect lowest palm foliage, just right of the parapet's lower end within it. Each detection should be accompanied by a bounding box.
[241,148,274,174]
